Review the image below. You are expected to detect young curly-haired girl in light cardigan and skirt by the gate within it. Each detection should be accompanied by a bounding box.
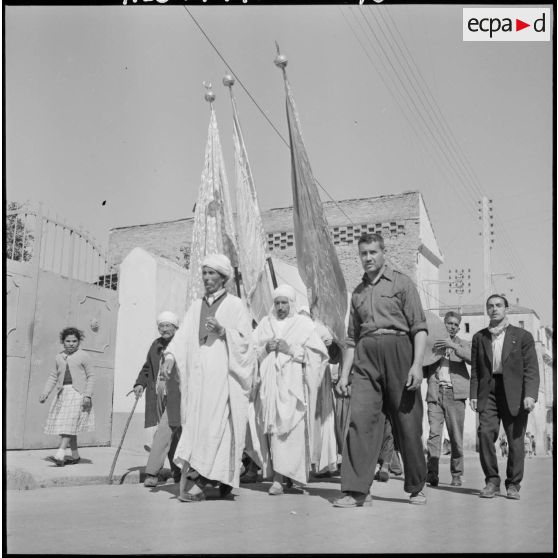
[39,327,95,467]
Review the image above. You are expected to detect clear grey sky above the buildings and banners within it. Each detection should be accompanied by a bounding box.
[4,3,555,325]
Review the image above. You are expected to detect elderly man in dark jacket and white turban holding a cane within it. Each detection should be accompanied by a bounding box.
[134,311,182,488]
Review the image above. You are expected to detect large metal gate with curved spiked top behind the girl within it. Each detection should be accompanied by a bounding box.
[4,206,118,449]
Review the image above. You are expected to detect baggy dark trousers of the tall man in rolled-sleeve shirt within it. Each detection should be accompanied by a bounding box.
[341,335,426,494]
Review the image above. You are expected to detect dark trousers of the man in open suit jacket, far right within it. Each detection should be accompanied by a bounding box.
[478,374,529,490]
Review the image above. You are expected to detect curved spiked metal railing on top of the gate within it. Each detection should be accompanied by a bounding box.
[5,204,117,290]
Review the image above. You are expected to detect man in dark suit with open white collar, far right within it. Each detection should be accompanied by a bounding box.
[470,295,539,500]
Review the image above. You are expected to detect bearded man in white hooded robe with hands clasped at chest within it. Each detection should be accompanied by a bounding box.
[252,285,328,495]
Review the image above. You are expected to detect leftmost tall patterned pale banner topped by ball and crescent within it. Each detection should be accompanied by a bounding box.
[186,90,238,309]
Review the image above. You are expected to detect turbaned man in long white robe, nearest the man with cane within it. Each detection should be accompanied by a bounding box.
[162,254,256,502]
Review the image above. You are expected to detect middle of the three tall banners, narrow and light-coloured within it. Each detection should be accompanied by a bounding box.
[223,76,273,322]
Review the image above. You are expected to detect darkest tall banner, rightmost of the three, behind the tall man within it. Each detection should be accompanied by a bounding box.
[275,49,347,345]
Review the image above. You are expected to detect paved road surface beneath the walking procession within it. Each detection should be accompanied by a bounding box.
[6,455,555,554]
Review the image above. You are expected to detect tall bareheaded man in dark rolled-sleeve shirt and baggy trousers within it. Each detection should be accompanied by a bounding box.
[333,234,428,508]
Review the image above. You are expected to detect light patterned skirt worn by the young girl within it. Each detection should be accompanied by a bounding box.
[44,384,95,436]
